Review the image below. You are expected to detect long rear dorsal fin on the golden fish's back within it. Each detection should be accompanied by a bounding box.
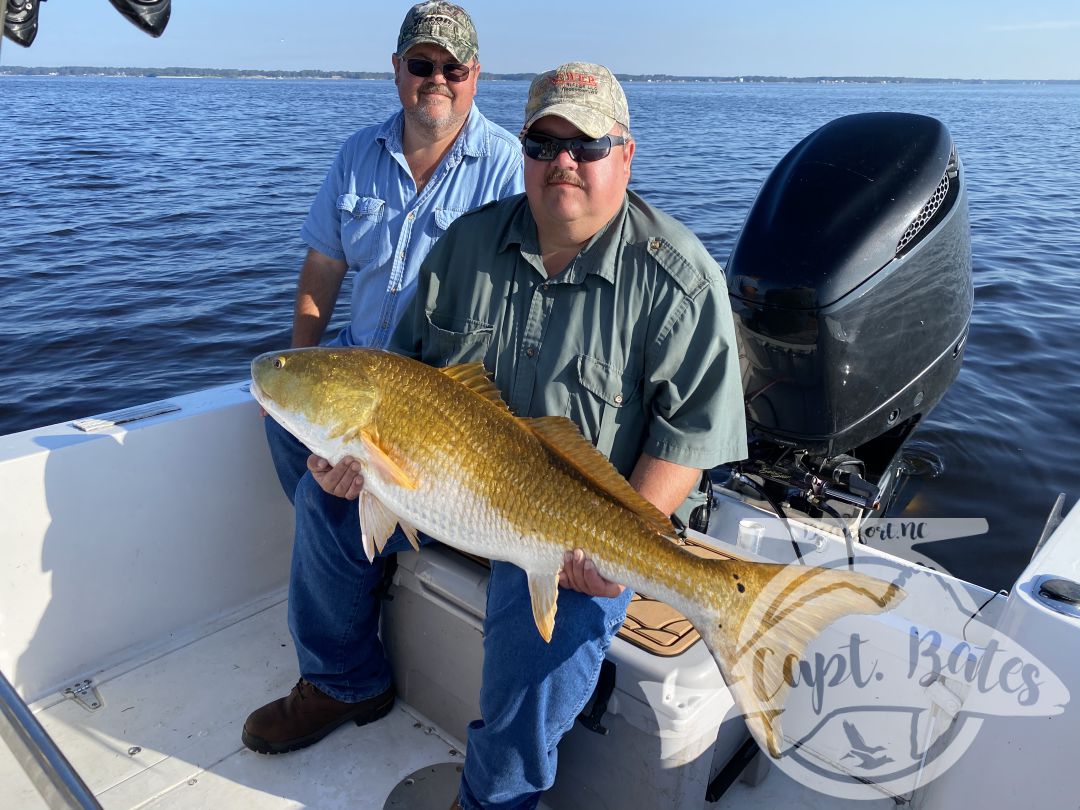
[522,416,674,537]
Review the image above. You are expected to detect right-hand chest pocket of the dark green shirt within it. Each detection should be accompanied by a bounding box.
[567,354,644,455]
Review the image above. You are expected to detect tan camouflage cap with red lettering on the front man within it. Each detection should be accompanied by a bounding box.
[522,62,630,138]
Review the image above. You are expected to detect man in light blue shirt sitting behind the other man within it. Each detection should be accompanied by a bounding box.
[243,2,522,754]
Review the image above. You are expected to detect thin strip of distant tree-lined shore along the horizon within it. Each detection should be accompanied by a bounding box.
[0,65,1080,84]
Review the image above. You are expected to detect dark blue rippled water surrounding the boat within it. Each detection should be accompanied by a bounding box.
[0,77,1080,588]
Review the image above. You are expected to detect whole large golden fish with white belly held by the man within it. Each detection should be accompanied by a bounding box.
[252,349,903,756]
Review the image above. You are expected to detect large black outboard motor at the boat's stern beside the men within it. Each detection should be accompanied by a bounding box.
[727,112,973,514]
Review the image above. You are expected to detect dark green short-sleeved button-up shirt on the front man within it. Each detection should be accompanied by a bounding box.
[390,192,746,516]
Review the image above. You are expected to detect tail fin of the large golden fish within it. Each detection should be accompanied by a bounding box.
[694,561,905,758]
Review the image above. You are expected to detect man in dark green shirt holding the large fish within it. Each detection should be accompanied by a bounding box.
[312,63,746,810]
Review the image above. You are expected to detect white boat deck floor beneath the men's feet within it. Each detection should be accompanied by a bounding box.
[0,597,893,810]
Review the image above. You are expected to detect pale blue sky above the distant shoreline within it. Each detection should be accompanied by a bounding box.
[0,0,1080,79]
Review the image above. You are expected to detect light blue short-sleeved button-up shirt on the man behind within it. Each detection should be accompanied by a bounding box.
[300,105,525,349]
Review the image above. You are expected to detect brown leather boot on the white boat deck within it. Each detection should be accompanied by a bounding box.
[241,678,394,754]
